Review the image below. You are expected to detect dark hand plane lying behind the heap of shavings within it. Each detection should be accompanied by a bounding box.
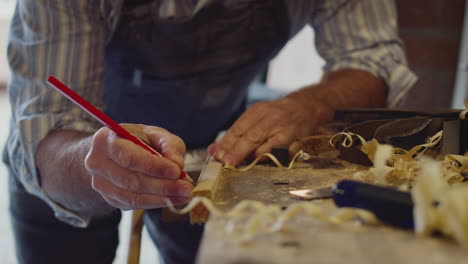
[335,109,468,166]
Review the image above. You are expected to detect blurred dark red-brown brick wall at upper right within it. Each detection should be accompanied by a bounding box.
[397,0,465,108]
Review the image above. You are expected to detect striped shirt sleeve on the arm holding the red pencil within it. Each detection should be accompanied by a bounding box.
[6,0,106,227]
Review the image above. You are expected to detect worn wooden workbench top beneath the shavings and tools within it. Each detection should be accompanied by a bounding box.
[197,159,468,264]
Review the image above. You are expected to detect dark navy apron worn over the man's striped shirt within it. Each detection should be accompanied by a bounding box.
[104,0,289,148]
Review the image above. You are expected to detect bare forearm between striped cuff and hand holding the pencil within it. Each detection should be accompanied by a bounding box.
[36,130,113,216]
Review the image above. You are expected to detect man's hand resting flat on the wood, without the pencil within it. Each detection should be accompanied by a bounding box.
[209,94,333,165]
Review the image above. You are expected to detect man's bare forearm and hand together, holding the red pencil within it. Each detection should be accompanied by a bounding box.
[36,124,193,215]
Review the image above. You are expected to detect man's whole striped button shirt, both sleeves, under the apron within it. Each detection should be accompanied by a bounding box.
[6,0,416,227]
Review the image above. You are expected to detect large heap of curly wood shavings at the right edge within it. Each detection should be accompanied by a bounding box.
[331,101,468,247]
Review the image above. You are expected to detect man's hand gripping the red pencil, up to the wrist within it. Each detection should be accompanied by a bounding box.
[85,124,193,210]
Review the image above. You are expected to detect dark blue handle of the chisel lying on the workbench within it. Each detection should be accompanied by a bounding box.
[332,180,414,228]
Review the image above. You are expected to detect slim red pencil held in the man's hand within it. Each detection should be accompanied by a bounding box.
[47,76,194,183]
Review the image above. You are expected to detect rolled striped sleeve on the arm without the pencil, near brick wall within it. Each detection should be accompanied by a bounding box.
[311,0,417,107]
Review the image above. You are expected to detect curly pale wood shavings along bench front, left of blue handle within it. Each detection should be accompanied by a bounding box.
[168,197,379,244]
